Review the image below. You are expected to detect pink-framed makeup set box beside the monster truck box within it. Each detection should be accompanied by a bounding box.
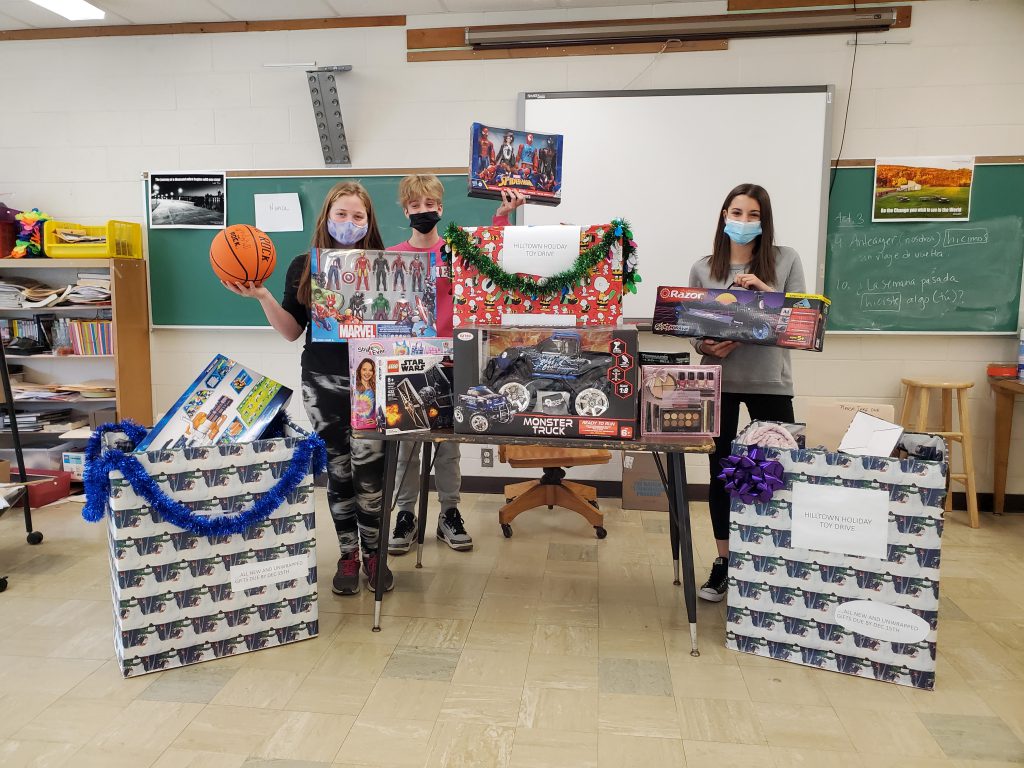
[640,366,722,437]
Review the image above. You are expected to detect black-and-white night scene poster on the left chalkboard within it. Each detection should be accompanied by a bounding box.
[150,171,227,229]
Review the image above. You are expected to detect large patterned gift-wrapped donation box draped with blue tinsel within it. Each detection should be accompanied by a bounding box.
[105,424,318,677]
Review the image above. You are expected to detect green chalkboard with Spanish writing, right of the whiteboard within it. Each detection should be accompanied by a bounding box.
[824,165,1024,333]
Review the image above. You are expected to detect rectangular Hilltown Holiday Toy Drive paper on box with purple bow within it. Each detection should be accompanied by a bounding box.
[793,482,889,559]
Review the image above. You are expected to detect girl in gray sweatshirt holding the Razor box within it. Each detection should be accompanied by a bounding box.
[686,184,805,602]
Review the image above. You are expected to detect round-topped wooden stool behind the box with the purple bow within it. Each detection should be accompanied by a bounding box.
[900,379,981,528]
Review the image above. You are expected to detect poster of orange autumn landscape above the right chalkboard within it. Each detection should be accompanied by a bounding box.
[871,157,974,221]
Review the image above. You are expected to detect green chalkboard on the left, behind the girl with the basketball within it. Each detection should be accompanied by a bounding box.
[146,174,498,327]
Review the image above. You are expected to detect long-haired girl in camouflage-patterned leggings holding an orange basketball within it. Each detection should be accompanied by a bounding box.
[222,181,394,595]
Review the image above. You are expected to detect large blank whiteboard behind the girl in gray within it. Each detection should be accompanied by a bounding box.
[519,85,833,318]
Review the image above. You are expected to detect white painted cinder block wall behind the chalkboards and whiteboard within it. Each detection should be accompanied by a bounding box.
[0,0,1024,494]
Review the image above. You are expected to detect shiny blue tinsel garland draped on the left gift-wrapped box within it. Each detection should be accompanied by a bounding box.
[82,421,327,536]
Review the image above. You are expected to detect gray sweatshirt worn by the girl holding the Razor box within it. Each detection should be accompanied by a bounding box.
[686,246,806,395]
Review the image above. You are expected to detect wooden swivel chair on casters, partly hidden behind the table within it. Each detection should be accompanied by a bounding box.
[498,445,611,539]
